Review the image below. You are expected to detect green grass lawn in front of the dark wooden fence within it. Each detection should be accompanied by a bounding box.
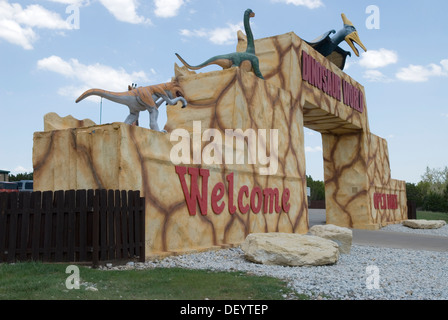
[0,262,307,300]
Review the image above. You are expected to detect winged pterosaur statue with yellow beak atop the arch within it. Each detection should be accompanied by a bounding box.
[307,13,367,70]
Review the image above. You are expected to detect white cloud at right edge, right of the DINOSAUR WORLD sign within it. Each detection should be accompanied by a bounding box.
[396,59,448,82]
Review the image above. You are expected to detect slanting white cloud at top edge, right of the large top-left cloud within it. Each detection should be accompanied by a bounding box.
[100,0,151,24]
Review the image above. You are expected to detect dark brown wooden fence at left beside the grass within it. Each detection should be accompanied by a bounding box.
[0,190,145,266]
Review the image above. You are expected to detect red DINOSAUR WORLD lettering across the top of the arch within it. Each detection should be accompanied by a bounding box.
[302,51,364,113]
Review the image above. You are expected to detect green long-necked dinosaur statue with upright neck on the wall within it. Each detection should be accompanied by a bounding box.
[176,9,264,79]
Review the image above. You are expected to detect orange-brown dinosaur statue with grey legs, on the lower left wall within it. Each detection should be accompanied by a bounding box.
[76,80,187,131]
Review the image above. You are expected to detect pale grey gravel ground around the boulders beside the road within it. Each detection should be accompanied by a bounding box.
[102,225,448,300]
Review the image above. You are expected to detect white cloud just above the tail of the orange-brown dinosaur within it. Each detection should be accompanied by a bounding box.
[37,56,149,98]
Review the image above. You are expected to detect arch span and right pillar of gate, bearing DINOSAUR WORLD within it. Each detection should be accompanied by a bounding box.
[238,32,407,229]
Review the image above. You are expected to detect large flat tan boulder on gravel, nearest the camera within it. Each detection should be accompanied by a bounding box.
[241,233,339,266]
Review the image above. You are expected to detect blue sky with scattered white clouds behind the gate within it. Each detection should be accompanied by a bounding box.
[0,0,448,183]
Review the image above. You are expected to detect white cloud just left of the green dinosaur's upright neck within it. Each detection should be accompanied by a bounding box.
[180,23,243,45]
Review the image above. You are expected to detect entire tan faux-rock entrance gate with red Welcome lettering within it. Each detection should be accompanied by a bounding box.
[33,33,407,256]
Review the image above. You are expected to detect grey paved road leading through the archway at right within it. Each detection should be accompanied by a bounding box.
[309,209,448,252]
